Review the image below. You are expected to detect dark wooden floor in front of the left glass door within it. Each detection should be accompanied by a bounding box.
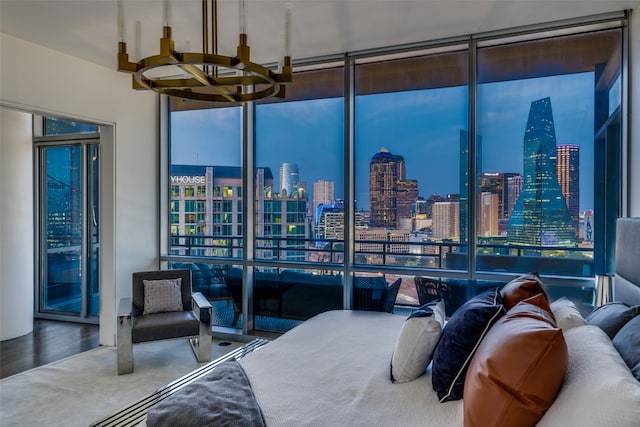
[0,319,100,378]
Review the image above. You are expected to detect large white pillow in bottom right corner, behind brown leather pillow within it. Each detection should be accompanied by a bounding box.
[537,325,640,427]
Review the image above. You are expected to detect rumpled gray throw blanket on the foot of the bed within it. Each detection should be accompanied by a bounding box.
[147,360,265,427]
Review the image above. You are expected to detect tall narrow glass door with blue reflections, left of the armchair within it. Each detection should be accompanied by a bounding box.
[35,118,100,321]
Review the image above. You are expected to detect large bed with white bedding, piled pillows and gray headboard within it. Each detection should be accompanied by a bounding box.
[95,218,640,427]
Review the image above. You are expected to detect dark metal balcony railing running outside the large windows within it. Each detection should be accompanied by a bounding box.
[171,235,594,277]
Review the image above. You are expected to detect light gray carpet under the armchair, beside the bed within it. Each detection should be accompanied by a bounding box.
[0,339,243,427]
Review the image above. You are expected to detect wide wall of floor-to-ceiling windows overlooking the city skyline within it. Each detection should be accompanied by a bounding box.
[163,12,626,329]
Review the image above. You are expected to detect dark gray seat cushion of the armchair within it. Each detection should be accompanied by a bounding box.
[131,311,200,343]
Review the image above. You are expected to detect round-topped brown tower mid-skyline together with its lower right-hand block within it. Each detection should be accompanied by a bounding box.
[369,148,418,228]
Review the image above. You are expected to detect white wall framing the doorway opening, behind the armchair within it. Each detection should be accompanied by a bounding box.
[0,33,159,345]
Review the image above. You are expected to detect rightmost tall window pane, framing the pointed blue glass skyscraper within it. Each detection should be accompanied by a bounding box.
[476,29,622,304]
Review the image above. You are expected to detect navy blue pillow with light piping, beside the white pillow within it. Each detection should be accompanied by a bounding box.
[431,288,505,402]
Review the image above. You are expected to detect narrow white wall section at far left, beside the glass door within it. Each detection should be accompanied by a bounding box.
[0,108,34,340]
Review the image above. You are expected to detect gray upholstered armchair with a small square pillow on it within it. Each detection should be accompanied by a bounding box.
[117,270,212,375]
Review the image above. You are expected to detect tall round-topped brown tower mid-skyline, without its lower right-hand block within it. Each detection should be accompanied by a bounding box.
[369,148,404,228]
